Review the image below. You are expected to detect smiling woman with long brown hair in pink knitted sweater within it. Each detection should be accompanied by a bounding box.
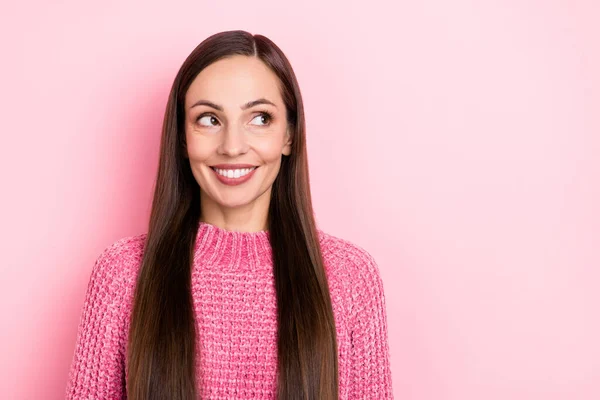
[67,31,392,400]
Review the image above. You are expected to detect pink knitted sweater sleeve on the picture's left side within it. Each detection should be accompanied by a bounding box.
[66,241,126,400]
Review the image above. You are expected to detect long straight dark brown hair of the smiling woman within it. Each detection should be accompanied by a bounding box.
[127,30,338,400]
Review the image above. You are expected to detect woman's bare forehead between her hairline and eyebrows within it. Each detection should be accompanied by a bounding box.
[185,55,283,110]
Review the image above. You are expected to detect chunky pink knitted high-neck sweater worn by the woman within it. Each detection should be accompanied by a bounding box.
[66,222,393,400]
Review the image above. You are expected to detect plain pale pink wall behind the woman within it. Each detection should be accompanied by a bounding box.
[0,0,600,400]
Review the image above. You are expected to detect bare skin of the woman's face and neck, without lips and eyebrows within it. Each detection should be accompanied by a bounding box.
[185,55,291,232]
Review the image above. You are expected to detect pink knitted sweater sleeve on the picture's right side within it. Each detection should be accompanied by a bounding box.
[349,248,393,400]
